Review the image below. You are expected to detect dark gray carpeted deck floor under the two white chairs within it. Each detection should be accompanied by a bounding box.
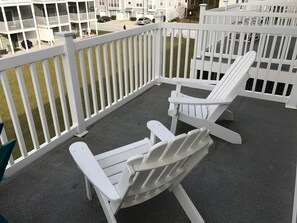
[0,84,297,223]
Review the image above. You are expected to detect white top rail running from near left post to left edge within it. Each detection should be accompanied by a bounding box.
[0,45,64,71]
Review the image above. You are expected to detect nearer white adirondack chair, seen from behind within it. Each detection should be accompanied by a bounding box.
[69,121,212,223]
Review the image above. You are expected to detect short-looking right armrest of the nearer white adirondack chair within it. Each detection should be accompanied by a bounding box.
[147,120,174,143]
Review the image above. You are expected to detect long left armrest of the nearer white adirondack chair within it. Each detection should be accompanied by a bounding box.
[69,142,121,200]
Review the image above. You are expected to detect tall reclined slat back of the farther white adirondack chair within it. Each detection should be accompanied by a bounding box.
[207,51,256,121]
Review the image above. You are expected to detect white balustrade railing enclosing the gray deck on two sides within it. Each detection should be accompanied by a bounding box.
[0,23,297,178]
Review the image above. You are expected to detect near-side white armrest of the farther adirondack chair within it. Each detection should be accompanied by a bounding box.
[168,96,232,105]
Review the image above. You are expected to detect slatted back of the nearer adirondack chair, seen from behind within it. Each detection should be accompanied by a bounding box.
[117,128,212,208]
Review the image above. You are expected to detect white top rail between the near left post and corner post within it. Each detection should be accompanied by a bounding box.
[75,23,160,50]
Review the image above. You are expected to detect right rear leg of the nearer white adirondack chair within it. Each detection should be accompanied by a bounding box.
[172,184,205,223]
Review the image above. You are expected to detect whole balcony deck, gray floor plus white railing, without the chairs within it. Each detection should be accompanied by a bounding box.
[0,8,297,223]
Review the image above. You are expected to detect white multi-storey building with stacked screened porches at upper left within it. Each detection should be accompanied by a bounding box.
[0,0,97,53]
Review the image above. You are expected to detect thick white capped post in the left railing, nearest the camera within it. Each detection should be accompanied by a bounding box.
[56,32,87,137]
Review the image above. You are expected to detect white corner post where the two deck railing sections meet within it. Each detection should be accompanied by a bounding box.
[153,15,164,84]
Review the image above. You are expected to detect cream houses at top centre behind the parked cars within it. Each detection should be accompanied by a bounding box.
[96,0,186,20]
